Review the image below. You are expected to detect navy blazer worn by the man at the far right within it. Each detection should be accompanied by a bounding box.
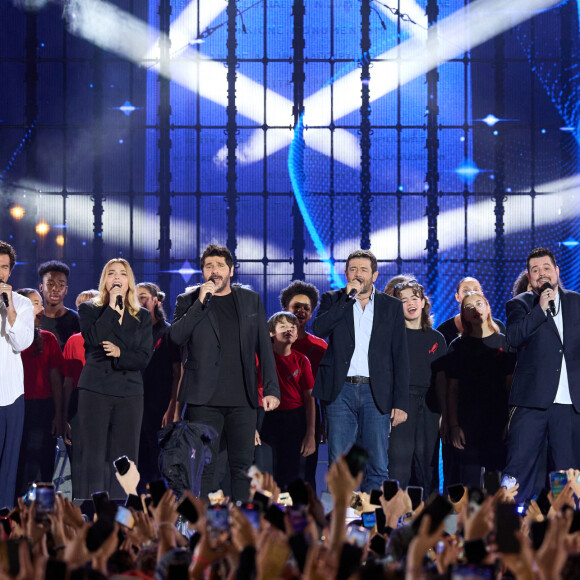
[506,288,580,412]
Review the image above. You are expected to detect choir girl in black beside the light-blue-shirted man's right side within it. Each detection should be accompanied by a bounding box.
[389,280,447,495]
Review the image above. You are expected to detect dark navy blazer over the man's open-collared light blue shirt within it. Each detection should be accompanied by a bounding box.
[312,288,410,413]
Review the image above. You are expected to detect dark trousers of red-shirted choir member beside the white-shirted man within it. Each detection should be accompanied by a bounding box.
[16,397,56,496]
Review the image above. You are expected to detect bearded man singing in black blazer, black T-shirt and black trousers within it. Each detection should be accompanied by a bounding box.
[170,244,280,501]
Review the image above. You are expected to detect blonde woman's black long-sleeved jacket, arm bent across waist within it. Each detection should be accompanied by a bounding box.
[79,302,153,397]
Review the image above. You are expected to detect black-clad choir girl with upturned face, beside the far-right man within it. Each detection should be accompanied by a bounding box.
[446,292,515,487]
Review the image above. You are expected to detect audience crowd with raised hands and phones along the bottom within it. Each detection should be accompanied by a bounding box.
[5,456,580,580]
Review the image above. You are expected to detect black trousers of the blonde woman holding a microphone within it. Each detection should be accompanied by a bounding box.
[78,389,143,499]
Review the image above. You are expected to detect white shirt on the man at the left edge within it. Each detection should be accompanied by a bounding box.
[0,292,34,407]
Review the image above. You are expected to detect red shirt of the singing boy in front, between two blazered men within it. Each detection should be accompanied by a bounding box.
[274,351,314,411]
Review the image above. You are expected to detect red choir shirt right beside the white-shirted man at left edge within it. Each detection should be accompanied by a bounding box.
[20,330,63,400]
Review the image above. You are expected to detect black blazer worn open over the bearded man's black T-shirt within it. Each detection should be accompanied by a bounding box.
[170,284,280,408]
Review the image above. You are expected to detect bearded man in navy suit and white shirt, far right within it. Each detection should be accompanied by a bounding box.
[504,248,580,501]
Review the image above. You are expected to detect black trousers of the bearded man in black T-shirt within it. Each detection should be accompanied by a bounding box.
[184,405,256,501]
